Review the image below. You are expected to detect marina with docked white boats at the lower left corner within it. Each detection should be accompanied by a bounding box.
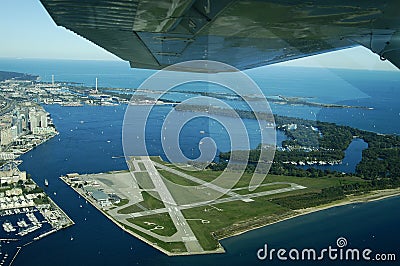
[0,169,74,266]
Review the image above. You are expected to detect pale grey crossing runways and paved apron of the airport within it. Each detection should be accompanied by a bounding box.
[70,156,306,254]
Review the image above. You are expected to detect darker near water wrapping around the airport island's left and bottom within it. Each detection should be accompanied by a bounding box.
[10,105,400,265]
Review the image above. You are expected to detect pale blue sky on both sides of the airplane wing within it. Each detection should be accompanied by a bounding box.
[0,0,398,70]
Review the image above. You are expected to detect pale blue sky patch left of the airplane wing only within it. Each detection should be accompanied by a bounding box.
[0,0,119,60]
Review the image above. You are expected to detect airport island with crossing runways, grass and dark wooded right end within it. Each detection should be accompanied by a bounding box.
[61,109,400,256]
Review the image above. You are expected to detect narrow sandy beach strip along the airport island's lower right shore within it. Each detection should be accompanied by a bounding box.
[218,188,400,241]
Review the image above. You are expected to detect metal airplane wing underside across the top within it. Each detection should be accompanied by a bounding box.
[40,0,400,71]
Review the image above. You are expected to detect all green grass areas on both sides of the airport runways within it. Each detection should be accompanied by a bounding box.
[119,157,365,254]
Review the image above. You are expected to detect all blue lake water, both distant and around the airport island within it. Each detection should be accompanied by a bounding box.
[0,59,400,265]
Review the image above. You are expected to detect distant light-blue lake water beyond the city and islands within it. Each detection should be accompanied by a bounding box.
[0,58,400,134]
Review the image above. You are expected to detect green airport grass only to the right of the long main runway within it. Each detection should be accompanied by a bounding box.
[150,163,362,250]
